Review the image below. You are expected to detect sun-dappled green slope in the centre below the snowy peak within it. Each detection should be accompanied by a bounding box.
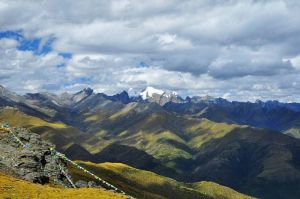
[79,104,244,167]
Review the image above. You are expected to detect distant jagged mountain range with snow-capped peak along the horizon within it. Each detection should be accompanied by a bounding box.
[0,86,300,137]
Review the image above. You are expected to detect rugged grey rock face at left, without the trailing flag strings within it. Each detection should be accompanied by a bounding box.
[0,128,71,187]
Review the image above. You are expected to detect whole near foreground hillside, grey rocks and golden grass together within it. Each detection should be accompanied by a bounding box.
[0,123,255,199]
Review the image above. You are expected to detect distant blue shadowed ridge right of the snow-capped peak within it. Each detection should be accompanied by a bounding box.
[164,101,300,132]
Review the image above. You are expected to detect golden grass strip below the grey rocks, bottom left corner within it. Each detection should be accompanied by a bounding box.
[0,173,126,199]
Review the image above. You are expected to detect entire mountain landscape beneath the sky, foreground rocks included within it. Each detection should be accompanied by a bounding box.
[0,84,300,198]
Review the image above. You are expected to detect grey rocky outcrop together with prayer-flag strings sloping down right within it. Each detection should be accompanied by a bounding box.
[0,128,127,193]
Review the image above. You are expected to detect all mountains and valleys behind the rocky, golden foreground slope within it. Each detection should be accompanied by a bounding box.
[0,84,300,199]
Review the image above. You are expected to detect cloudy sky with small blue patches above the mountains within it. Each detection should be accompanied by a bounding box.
[0,0,300,102]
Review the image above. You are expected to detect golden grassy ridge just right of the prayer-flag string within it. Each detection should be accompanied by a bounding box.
[71,161,204,199]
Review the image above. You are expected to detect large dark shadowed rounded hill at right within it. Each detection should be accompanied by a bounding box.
[191,128,300,198]
